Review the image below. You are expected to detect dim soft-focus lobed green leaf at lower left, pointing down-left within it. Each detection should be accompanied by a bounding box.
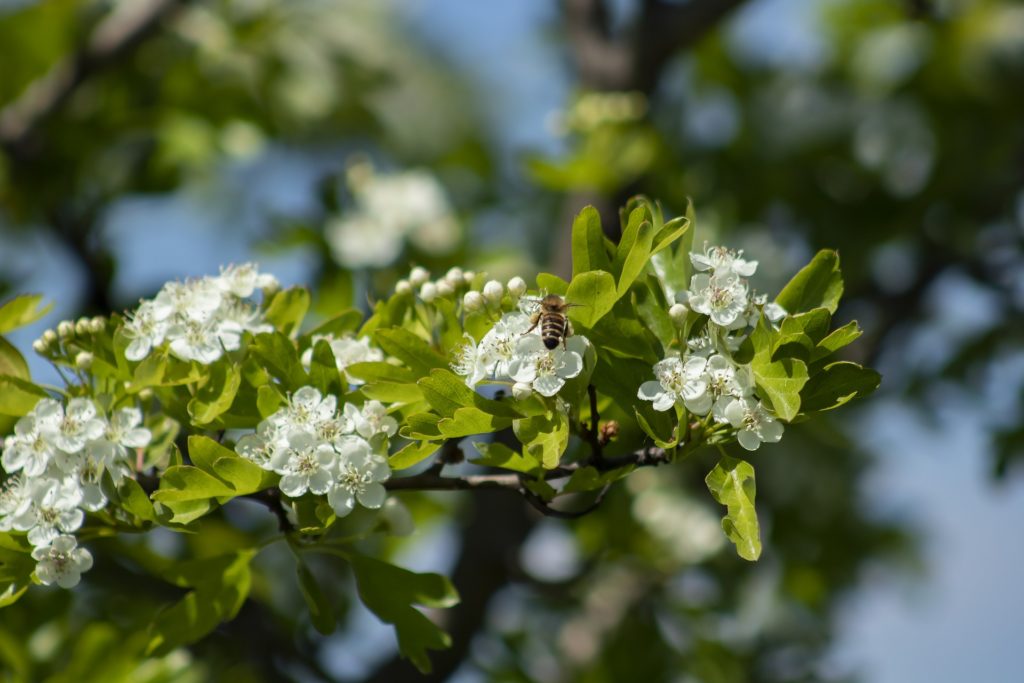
[145,550,256,656]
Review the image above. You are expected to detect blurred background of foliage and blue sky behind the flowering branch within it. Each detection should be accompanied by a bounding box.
[0,0,1024,683]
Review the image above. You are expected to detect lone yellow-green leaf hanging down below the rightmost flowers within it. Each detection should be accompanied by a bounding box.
[705,456,761,561]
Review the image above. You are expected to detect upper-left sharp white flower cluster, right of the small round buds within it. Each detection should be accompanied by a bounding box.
[124,263,278,365]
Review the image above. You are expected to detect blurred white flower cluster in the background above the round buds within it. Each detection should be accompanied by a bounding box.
[325,163,461,268]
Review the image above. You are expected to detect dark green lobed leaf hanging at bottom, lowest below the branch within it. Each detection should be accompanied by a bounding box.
[351,554,459,674]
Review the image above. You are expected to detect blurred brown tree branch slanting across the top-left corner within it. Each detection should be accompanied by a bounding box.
[0,0,190,160]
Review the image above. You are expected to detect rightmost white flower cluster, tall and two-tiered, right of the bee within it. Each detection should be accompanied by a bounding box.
[637,246,785,451]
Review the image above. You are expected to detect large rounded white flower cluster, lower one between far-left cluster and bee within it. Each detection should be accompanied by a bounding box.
[236,386,398,517]
